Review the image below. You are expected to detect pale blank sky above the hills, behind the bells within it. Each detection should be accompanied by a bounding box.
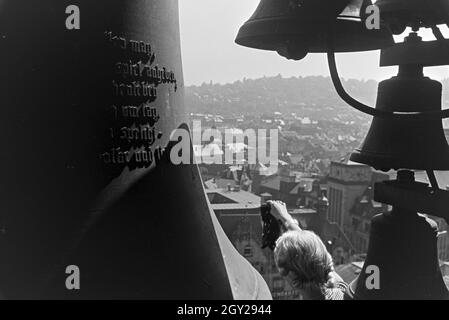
[179,0,449,85]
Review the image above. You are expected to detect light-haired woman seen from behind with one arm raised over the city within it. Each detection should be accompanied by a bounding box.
[269,201,347,300]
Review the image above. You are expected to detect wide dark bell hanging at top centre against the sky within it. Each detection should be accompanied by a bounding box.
[236,0,394,60]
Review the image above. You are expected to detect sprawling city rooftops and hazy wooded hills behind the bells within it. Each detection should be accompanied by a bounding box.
[186,76,449,299]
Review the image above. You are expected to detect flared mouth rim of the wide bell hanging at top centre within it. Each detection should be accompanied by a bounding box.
[235,16,395,53]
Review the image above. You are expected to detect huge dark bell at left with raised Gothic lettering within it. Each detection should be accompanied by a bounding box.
[0,0,271,300]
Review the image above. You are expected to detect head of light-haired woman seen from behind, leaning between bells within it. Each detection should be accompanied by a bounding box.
[274,230,333,289]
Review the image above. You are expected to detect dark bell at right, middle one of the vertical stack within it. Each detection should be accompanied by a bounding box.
[351,65,449,171]
